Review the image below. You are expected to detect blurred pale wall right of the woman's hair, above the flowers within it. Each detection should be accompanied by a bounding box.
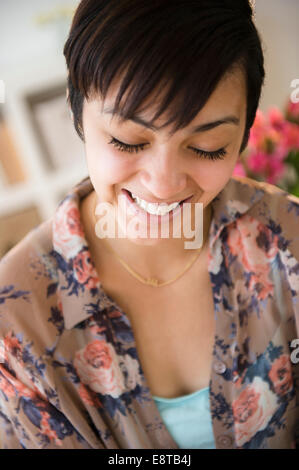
[256,0,299,111]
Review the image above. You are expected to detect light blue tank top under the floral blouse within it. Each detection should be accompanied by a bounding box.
[153,387,216,449]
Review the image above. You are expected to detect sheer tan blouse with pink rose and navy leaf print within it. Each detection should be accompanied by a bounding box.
[0,176,299,449]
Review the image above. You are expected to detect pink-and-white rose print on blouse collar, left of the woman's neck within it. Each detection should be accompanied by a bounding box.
[53,199,85,258]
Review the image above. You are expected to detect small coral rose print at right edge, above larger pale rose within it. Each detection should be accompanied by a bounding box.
[269,354,293,395]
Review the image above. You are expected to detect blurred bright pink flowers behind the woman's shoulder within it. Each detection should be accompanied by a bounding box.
[233,100,299,197]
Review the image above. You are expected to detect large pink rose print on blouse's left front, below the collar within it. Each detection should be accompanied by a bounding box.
[74,339,125,398]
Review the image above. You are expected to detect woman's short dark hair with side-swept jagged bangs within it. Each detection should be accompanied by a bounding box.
[63,0,265,153]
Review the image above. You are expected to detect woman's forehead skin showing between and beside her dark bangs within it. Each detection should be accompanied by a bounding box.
[88,68,246,128]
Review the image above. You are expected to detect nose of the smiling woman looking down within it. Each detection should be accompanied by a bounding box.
[141,151,187,200]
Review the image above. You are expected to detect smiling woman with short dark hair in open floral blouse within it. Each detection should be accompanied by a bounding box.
[0,0,299,449]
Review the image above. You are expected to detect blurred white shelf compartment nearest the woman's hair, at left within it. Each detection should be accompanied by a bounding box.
[25,83,84,171]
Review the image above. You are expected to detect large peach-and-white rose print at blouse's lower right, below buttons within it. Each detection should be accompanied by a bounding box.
[232,377,279,447]
